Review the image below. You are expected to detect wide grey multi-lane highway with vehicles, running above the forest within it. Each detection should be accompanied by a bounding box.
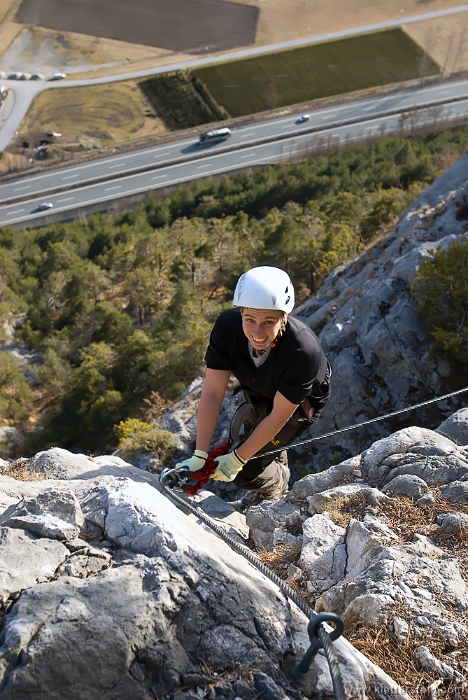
[0,80,468,225]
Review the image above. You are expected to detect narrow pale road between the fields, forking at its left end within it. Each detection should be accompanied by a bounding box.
[0,5,468,151]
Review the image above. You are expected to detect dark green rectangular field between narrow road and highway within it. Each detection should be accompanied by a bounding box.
[194,28,440,117]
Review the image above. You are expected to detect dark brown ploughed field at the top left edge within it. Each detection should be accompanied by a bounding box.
[15,0,259,54]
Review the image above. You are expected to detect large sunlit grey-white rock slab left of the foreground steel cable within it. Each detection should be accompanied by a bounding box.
[0,449,382,700]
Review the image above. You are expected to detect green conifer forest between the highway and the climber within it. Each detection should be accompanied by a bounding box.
[0,128,468,454]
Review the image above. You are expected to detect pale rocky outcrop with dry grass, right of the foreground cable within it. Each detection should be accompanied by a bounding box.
[247,415,468,697]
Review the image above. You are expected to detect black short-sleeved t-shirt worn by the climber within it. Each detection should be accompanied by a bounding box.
[205,308,328,404]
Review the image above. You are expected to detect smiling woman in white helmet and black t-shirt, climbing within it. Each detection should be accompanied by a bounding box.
[176,267,331,505]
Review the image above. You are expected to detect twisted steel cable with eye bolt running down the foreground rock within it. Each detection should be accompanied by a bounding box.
[160,464,346,700]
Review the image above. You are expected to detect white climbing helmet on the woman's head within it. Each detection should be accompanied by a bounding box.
[232,266,294,314]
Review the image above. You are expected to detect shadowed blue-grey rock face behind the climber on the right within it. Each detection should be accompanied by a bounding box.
[295,154,468,469]
